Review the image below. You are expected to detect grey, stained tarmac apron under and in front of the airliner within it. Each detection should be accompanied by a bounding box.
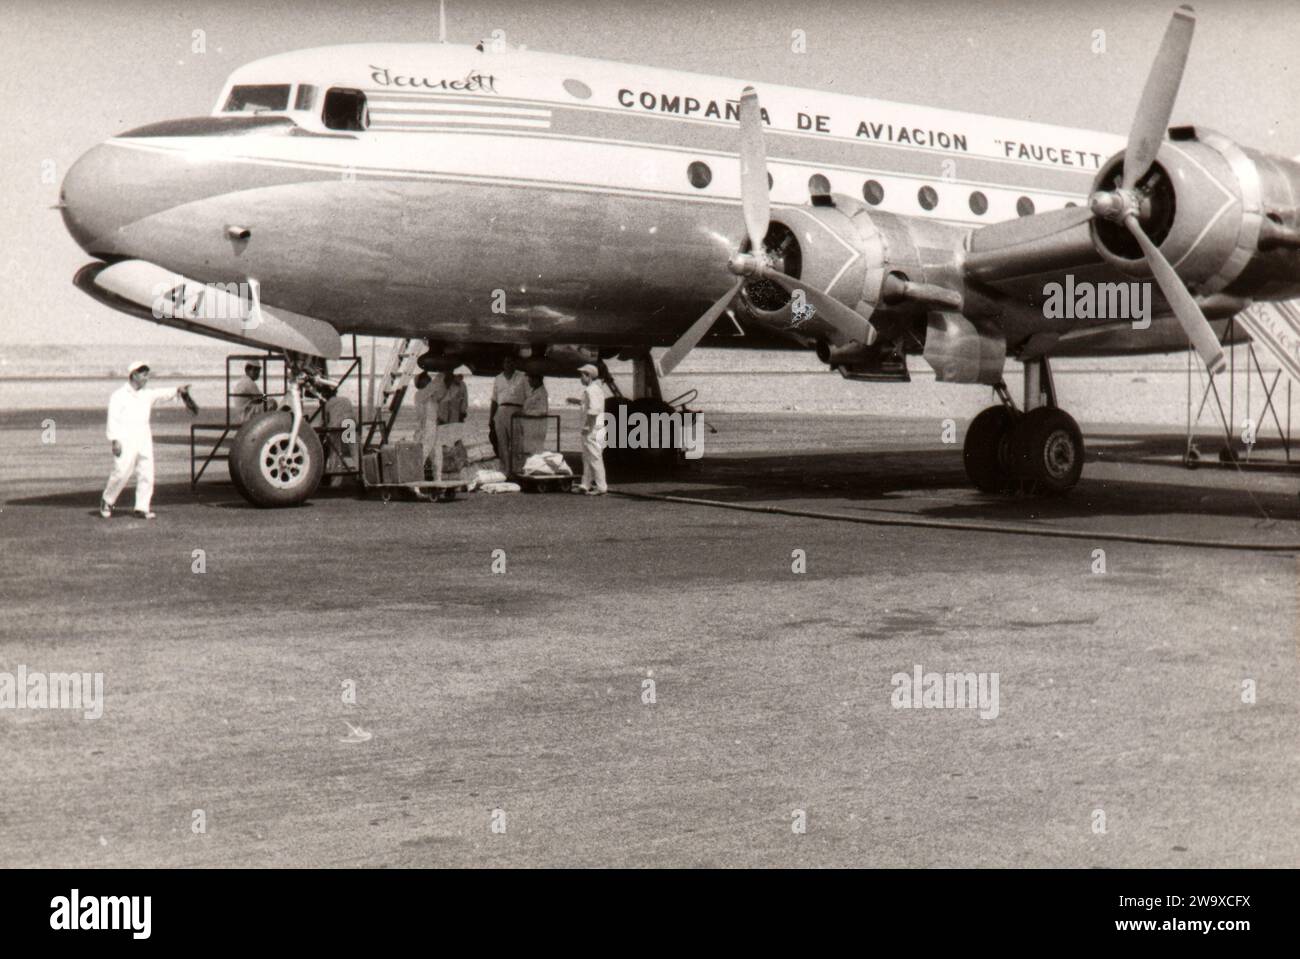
[0,402,1300,867]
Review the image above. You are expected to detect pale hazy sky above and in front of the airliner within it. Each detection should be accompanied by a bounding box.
[0,0,1300,343]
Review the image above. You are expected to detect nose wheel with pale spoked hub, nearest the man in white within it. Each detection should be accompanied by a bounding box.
[230,411,325,508]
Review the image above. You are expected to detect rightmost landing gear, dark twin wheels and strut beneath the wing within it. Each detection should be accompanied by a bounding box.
[962,357,1084,492]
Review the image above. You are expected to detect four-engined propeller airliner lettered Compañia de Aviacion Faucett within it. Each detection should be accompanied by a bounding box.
[61,8,1300,505]
